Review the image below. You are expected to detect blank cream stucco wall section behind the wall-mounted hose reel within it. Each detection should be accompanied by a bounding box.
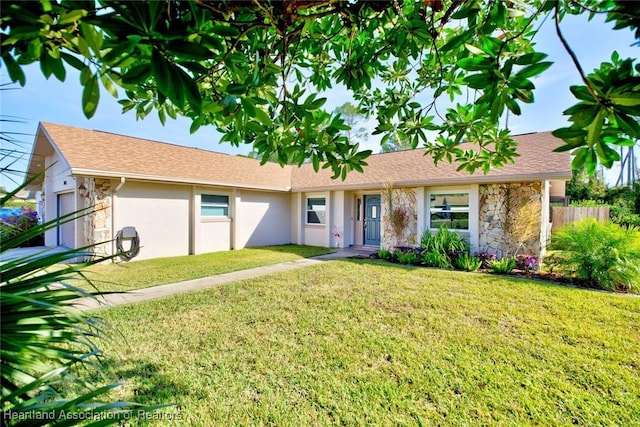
[113,181,191,260]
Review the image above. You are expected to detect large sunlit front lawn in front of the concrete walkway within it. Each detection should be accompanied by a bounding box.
[98,260,640,426]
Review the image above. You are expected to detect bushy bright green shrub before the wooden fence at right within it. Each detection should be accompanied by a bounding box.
[549,218,640,291]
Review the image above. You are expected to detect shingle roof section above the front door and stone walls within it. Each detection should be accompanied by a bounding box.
[292,132,571,191]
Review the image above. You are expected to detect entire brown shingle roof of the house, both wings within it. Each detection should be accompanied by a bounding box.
[29,123,571,191]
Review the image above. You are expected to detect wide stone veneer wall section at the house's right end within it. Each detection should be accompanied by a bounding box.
[478,182,543,258]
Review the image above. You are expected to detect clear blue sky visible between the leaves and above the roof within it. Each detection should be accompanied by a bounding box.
[0,11,638,187]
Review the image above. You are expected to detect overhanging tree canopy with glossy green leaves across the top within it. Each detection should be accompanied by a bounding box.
[0,0,640,178]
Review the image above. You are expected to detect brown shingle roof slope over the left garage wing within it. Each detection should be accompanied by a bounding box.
[36,123,291,190]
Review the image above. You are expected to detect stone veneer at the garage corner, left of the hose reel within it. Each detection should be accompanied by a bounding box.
[78,178,112,255]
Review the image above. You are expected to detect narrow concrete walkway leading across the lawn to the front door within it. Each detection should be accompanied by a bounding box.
[74,249,376,311]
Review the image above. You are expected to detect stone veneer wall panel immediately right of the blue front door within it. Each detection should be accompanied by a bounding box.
[380,188,418,248]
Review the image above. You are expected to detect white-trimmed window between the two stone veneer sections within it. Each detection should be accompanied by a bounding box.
[427,191,469,230]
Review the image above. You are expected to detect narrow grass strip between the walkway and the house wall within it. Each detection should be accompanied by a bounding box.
[72,245,331,292]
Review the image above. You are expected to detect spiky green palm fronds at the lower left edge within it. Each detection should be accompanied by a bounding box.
[0,184,162,426]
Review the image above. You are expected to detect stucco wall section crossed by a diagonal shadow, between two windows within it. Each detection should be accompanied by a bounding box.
[234,190,293,249]
